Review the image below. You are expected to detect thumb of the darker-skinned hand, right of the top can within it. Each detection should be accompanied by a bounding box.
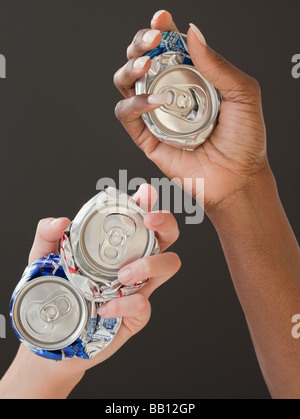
[187,23,258,103]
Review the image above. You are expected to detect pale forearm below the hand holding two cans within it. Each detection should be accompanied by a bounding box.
[0,345,84,399]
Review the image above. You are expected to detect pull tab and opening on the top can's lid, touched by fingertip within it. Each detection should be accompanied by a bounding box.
[158,85,207,122]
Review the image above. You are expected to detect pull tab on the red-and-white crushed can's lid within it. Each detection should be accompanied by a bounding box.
[100,214,136,265]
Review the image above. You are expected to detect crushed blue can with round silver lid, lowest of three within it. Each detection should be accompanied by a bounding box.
[10,254,121,361]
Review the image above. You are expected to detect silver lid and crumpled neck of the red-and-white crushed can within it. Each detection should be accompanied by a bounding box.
[70,188,155,281]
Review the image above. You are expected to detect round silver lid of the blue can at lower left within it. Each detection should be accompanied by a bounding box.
[12,276,89,351]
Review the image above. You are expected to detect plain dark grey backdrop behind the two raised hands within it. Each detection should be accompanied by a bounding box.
[0,0,300,398]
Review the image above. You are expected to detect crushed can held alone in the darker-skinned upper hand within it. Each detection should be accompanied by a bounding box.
[136,32,221,151]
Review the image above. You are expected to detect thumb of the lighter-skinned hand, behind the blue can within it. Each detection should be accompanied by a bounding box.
[29,218,70,264]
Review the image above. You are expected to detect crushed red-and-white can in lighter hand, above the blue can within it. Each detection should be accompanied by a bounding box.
[61,188,160,304]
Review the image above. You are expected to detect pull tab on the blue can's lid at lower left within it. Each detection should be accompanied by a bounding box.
[40,295,72,323]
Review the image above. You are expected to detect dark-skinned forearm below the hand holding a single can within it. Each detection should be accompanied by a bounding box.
[211,167,300,398]
